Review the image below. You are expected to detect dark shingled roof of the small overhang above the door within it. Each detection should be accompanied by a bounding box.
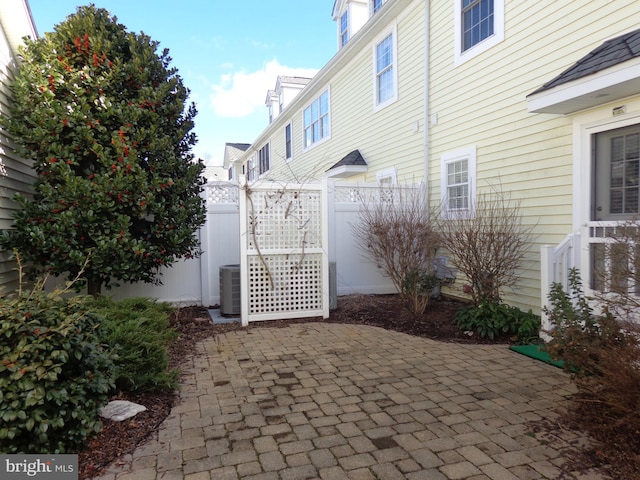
[533,29,640,93]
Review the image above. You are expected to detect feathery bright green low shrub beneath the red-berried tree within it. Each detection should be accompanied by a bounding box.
[88,297,179,391]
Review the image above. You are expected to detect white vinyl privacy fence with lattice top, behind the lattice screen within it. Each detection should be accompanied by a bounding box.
[112,180,396,313]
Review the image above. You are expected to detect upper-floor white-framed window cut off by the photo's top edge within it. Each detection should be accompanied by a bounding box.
[455,0,504,64]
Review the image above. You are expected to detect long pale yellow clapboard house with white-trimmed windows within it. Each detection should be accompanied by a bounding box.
[239,0,640,313]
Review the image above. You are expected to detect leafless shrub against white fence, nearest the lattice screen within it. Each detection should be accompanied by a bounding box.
[351,186,440,313]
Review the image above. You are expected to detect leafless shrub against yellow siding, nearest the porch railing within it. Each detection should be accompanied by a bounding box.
[439,189,533,305]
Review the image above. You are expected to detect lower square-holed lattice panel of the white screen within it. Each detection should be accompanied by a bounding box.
[248,253,323,315]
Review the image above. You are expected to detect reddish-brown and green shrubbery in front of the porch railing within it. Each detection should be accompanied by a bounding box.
[545,269,640,478]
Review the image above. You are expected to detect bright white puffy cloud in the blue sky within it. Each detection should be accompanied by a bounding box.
[211,59,317,117]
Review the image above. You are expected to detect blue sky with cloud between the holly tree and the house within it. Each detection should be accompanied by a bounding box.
[29,0,337,165]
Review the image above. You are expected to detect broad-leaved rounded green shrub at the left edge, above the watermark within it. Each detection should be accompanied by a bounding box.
[0,288,114,453]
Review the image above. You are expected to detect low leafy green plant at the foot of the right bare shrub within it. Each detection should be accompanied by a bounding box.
[456,300,540,344]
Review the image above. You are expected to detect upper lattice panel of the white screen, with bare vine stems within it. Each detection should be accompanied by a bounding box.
[247,190,322,252]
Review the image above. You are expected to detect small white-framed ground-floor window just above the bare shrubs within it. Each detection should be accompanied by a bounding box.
[441,147,476,218]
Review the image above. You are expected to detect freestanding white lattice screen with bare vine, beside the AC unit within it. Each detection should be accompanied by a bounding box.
[240,182,329,326]
